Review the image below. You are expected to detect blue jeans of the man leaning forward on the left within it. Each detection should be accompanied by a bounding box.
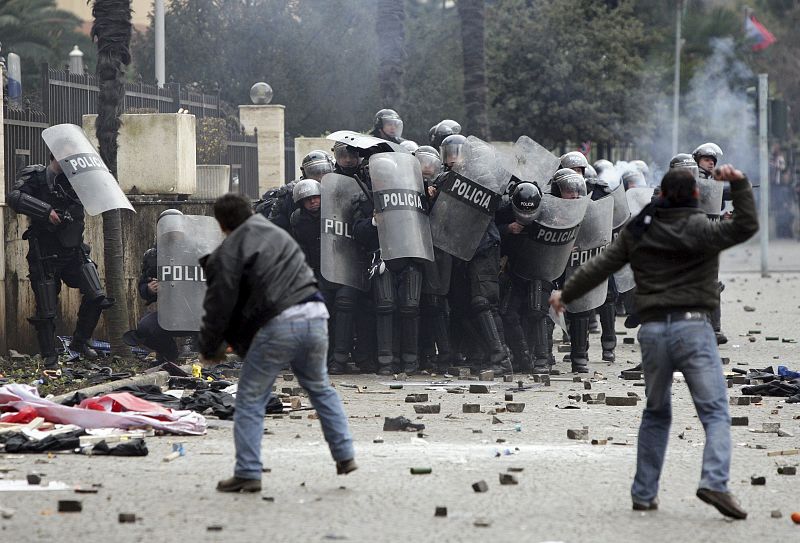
[233,319,354,479]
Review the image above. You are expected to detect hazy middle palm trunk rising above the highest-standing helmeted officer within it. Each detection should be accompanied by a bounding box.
[375,0,406,109]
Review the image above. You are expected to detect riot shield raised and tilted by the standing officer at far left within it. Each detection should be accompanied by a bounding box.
[42,124,135,215]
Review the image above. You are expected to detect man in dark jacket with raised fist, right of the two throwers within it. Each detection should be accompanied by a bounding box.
[550,165,758,519]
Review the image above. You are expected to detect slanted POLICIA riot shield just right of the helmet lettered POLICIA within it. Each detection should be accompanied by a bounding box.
[512,194,591,282]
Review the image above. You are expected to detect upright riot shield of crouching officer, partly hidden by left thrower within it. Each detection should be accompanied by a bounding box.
[156,215,224,332]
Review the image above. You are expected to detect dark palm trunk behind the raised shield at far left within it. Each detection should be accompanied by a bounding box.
[92,0,132,356]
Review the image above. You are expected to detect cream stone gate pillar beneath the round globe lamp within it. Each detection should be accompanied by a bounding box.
[239,104,286,194]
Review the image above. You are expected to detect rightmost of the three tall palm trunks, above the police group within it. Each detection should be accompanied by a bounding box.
[456,0,491,141]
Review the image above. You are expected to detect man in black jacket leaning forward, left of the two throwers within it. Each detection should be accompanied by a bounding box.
[200,194,357,492]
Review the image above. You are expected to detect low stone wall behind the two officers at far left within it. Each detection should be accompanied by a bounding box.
[0,201,213,353]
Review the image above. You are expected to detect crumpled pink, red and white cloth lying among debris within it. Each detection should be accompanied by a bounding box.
[0,384,206,435]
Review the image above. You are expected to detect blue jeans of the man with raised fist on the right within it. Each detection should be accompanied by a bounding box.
[631,320,731,503]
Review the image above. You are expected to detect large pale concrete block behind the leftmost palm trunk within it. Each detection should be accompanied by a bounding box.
[83,113,197,194]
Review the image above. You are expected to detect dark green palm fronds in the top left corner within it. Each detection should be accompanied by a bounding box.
[0,0,97,95]
